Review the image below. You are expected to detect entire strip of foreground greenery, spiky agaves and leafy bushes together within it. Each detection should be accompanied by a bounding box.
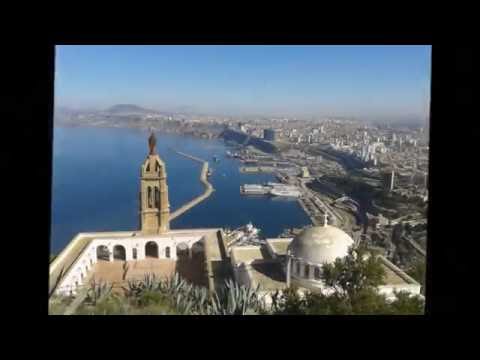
[50,248,424,315]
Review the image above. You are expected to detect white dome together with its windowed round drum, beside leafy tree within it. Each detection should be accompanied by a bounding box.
[286,222,354,288]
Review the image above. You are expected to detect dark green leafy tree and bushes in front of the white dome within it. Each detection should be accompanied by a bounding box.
[272,248,424,315]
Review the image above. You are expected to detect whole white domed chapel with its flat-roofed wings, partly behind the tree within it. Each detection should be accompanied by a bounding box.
[229,212,421,301]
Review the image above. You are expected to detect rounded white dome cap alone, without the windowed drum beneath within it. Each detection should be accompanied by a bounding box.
[288,225,353,264]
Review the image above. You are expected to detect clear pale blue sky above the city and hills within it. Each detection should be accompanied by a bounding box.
[55,45,431,121]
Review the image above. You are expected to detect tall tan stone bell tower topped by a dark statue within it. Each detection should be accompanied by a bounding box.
[140,132,170,234]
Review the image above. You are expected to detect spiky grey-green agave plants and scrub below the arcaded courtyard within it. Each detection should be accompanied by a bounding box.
[50,274,266,315]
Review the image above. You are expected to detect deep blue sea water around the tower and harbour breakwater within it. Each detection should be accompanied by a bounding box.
[51,127,311,254]
